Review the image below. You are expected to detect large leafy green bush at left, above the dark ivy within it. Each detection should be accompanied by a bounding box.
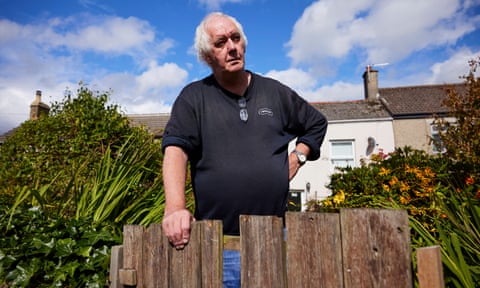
[0,85,134,207]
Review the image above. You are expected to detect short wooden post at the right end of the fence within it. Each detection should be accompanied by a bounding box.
[417,246,445,288]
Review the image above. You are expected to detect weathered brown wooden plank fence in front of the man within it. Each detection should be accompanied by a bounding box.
[110,209,443,288]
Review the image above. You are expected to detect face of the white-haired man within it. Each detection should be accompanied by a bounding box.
[205,17,245,74]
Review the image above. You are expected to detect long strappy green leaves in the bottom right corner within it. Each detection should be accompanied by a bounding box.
[410,184,480,288]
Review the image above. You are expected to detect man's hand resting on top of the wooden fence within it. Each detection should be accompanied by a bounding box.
[162,209,195,249]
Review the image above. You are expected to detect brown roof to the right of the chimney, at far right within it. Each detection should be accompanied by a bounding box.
[378,83,465,118]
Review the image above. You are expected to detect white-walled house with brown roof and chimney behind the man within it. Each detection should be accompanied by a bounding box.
[290,71,395,207]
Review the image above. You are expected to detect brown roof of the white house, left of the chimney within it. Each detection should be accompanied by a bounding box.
[312,100,391,121]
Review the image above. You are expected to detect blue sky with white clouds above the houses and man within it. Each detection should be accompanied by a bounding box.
[0,0,480,134]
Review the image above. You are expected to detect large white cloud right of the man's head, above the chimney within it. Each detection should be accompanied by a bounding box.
[287,0,478,71]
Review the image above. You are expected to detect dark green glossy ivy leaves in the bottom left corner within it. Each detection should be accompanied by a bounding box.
[0,205,121,287]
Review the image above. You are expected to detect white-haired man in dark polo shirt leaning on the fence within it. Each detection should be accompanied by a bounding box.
[162,9,327,266]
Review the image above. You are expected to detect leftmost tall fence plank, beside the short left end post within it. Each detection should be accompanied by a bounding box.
[122,225,145,287]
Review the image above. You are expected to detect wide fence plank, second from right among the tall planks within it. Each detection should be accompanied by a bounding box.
[286,212,343,288]
